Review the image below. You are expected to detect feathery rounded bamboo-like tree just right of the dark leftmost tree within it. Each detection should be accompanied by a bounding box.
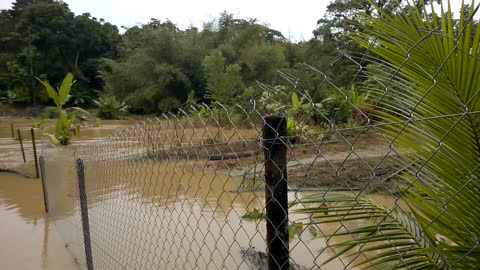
[101,19,192,113]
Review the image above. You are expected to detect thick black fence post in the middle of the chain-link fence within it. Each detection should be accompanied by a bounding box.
[262,116,290,270]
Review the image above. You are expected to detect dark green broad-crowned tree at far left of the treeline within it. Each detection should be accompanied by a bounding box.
[0,0,120,104]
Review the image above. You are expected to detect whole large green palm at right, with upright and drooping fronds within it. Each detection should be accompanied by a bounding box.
[296,1,480,269]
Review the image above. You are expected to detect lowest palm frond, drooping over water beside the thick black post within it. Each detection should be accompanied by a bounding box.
[295,193,435,269]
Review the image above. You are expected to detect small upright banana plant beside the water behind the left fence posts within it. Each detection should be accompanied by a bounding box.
[37,73,88,145]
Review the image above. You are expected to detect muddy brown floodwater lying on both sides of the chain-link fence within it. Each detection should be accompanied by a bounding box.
[0,118,404,269]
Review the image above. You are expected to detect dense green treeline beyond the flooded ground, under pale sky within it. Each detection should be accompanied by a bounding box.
[0,0,450,114]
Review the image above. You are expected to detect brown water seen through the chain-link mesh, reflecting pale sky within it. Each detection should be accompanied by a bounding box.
[45,151,356,269]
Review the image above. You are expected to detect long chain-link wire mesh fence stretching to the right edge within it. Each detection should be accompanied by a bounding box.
[43,3,480,269]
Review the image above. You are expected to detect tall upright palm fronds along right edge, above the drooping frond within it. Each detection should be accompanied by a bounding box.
[354,2,480,266]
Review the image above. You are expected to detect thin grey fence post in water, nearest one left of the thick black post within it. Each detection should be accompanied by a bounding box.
[76,158,93,270]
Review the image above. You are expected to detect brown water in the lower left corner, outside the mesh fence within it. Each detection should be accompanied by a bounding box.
[0,173,78,270]
